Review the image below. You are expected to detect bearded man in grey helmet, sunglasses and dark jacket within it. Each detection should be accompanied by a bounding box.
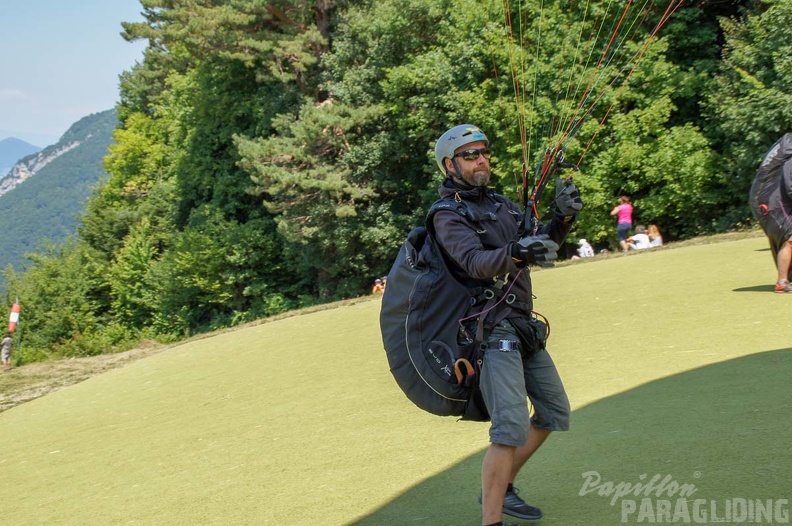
[430,124,583,525]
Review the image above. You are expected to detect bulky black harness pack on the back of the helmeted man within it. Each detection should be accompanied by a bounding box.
[380,194,549,421]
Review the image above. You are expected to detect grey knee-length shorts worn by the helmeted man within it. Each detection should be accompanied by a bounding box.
[481,320,570,446]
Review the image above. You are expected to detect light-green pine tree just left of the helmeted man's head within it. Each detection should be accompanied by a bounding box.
[232,102,395,298]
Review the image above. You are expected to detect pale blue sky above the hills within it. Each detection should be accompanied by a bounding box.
[0,0,146,148]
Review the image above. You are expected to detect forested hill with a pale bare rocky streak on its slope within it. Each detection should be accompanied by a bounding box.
[0,109,118,281]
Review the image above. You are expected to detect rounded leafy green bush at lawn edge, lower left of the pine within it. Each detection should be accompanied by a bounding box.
[146,207,294,335]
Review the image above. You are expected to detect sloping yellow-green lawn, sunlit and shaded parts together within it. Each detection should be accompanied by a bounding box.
[0,237,792,526]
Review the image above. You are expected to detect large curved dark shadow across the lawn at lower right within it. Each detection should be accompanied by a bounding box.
[353,350,792,526]
